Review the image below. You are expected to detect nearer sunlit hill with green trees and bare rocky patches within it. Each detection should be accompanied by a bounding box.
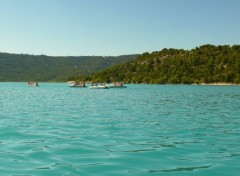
[87,45,240,84]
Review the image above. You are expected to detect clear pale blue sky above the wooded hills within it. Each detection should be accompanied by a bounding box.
[0,0,240,56]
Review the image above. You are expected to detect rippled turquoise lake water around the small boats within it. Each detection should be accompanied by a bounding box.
[0,83,240,176]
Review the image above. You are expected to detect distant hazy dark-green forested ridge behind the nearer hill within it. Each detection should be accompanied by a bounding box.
[0,53,138,81]
